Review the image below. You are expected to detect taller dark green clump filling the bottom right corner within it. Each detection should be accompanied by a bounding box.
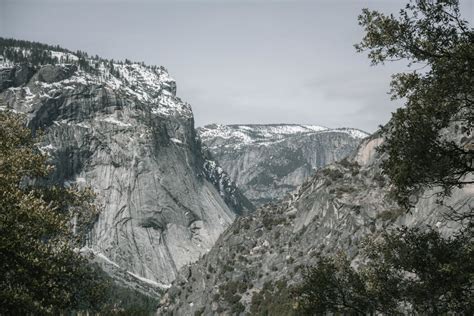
[361,227,474,315]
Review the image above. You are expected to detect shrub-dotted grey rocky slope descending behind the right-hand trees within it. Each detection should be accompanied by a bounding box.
[159,131,474,315]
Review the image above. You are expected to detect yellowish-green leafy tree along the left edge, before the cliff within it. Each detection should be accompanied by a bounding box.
[0,111,105,315]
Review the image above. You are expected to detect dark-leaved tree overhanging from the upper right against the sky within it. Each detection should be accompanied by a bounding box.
[356,0,474,211]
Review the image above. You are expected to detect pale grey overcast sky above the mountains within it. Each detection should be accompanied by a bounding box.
[0,0,474,132]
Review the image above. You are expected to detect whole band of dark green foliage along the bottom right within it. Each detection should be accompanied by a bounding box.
[294,228,474,315]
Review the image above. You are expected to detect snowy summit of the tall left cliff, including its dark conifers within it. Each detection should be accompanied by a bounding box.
[0,38,192,117]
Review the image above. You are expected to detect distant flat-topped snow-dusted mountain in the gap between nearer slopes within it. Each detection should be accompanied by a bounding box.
[197,124,368,206]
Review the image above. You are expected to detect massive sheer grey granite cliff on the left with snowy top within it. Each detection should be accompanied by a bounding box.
[0,39,253,292]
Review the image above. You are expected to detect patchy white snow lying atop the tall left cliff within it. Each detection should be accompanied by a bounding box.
[0,52,192,121]
